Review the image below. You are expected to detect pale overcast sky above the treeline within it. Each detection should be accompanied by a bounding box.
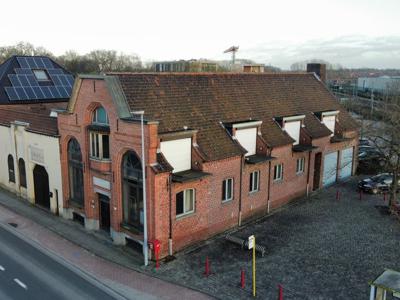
[0,0,400,68]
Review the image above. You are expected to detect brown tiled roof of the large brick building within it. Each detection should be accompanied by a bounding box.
[107,73,357,160]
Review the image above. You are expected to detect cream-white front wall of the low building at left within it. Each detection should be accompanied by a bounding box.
[0,125,63,214]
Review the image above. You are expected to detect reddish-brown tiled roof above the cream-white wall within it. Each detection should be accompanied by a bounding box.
[0,107,58,136]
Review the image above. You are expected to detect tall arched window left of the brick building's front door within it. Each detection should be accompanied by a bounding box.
[68,139,84,207]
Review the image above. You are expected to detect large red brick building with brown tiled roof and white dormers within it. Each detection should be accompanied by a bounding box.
[58,65,358,256]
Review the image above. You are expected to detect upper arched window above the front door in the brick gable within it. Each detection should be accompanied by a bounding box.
[90,107,110,160]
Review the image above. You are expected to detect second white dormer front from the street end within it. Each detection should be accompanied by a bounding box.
[231,121,262,156]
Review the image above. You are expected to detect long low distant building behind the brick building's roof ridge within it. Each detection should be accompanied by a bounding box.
[154,59,218,72]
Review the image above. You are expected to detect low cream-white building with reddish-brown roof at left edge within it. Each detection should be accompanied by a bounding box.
[0,109,63,215]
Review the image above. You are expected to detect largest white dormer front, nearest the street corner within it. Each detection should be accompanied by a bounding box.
[160,131,192,173]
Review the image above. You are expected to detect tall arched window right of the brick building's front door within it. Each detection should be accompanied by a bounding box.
[122,151,144,232]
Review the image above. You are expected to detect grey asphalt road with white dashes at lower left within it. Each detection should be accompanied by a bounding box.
[0,227,122,300]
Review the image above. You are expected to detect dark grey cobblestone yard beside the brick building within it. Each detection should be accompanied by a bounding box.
[154,178,400,299]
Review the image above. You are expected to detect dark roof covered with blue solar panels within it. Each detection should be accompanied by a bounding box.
[0,56,74,104]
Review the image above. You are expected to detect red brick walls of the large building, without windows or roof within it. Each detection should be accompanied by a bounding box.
[58,79,357,256]
